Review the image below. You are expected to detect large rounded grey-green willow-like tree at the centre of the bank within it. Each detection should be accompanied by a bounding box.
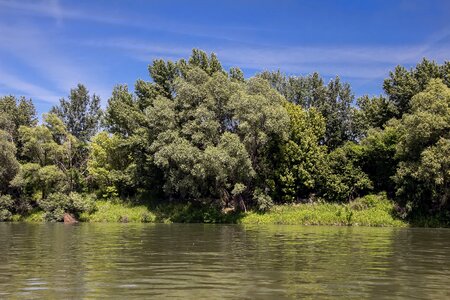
[146,67,288,207]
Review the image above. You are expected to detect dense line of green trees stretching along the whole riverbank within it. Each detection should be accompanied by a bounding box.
[0,50,450,220]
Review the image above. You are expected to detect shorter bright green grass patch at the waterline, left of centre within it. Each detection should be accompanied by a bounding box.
[79,201,156,223]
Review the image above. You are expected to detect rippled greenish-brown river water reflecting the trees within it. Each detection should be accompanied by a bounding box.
[0,223,450,299]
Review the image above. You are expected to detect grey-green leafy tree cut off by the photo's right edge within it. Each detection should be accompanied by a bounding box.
[394,79,450,213]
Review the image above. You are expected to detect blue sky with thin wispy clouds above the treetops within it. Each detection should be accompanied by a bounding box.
[0,0,450,113]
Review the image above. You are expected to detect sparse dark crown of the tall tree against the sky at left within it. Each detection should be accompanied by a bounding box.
[51,84,102,142]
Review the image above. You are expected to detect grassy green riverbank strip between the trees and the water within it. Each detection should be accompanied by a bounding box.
[16,195,412,227]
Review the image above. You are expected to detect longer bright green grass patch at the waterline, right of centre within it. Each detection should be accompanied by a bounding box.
[239,195,408,227]
